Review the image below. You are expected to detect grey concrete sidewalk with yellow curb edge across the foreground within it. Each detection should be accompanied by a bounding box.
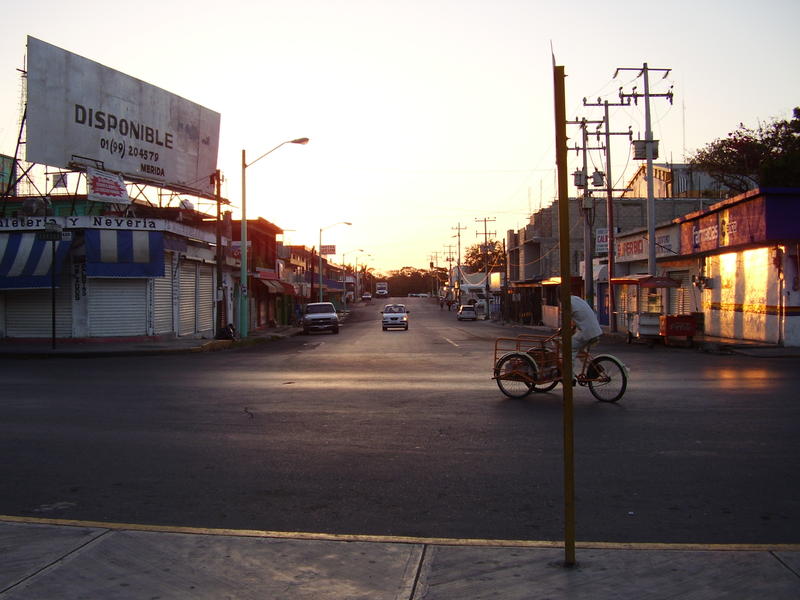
[0,517,800,600]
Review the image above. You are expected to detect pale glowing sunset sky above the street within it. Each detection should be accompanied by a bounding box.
[0,0,800,272]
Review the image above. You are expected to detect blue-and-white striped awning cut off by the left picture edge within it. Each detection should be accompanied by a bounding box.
[0,232,72,290]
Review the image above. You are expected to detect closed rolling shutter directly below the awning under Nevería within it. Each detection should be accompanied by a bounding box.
[89,277,147,337]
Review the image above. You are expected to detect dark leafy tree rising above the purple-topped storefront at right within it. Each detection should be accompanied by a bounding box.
[689,107,800,193]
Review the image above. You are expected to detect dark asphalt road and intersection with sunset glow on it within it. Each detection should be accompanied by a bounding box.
[0,298,800,543]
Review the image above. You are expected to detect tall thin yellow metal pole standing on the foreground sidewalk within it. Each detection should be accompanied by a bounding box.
[553,59,575,566]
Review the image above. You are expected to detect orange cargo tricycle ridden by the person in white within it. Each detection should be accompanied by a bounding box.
[492,332,628,402]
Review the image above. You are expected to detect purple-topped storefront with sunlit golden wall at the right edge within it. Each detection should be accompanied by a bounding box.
[677,188,800,346]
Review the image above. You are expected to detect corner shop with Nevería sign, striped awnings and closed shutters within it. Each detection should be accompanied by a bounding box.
[0,216,215,338]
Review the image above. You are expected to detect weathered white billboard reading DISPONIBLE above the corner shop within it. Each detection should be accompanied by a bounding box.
[26,36,220,196]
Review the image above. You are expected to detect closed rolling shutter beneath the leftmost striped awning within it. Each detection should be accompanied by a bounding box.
[6,276,72,337]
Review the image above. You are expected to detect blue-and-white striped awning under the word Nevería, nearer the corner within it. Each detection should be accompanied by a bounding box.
[84,229,164,277]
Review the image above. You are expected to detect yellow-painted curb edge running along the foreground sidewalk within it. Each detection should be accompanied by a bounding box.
[0,515,800,552]
